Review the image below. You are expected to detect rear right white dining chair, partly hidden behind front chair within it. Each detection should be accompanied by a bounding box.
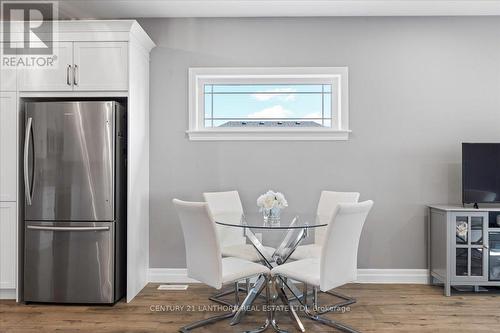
[290,191,359,260]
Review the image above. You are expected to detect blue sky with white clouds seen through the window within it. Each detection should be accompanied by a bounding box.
[204,84,332,127]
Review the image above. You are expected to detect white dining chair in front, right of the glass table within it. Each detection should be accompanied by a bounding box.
[271,200,373,332]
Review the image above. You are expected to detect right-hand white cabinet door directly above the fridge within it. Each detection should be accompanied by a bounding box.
[74,42,128,91]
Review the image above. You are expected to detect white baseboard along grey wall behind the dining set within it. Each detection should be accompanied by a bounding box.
[148,268,429,284]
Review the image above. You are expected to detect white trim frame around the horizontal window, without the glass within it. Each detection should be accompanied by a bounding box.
[186,67,351,141]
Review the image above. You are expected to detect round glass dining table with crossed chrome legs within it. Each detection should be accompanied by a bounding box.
[215,211,328,332]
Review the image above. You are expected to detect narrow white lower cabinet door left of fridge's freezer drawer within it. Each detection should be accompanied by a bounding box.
[0,202,17,291]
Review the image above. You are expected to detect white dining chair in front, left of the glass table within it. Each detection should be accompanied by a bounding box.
[173,199,269,332]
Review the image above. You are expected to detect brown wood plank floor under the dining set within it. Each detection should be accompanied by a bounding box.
[0,284,500,333]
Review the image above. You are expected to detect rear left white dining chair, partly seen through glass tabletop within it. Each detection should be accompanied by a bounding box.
[203,191,275,262]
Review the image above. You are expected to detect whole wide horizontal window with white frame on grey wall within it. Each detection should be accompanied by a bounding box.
[187,67,349,140]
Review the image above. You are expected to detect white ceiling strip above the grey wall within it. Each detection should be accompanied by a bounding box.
[55,0,500,19]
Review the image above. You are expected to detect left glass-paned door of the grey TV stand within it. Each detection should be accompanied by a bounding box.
[451,212,488,281]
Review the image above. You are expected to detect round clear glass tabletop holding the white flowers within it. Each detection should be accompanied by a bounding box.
[214,212,329,229]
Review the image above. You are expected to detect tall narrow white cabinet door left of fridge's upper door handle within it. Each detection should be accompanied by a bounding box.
[0,92,17,201]
